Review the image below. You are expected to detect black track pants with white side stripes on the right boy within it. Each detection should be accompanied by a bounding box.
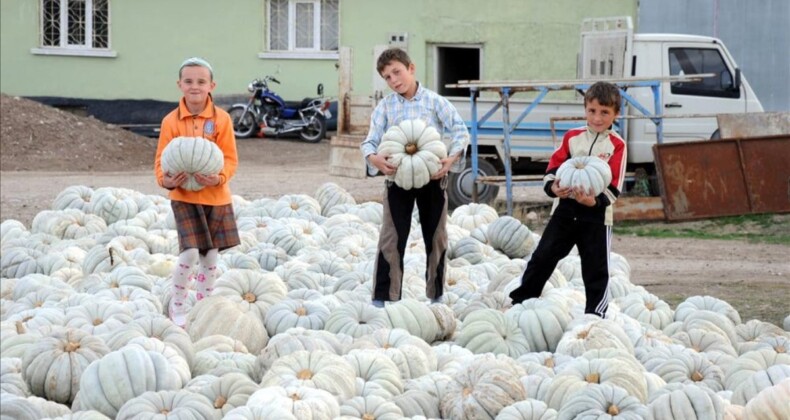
[510,216,612,317]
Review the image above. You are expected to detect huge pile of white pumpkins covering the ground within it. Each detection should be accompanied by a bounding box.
[0,183,790,420]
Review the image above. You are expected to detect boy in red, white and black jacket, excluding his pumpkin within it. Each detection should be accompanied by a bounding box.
[510,82,626,317]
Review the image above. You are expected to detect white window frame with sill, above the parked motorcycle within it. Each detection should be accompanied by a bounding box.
[258,0,340,60]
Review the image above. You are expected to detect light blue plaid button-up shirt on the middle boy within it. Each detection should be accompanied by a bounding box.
[359,83,469,176]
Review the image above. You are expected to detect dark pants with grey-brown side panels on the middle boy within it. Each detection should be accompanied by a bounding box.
[373,177,447,301]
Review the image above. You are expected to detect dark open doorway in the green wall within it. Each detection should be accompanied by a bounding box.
[436,47,480,97]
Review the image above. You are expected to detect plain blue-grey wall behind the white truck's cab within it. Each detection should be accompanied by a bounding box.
[638,0,790,111]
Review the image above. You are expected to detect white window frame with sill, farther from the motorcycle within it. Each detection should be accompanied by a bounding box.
[30,0,118,57]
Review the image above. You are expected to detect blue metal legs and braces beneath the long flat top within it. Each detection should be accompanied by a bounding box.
[464,80,664,216]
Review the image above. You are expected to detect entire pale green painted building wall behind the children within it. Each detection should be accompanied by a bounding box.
[0,0,637,100]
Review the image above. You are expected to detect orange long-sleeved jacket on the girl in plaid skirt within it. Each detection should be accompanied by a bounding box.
[154,95,239,206]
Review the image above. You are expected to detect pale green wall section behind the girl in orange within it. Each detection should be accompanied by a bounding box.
[0,0,337,101]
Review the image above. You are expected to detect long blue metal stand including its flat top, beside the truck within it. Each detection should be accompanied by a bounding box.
[446,73,714,215]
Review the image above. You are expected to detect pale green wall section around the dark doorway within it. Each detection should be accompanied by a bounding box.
[341,0,637,99]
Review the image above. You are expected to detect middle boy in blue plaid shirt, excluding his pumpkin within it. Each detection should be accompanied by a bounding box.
[360,48,469,307]
